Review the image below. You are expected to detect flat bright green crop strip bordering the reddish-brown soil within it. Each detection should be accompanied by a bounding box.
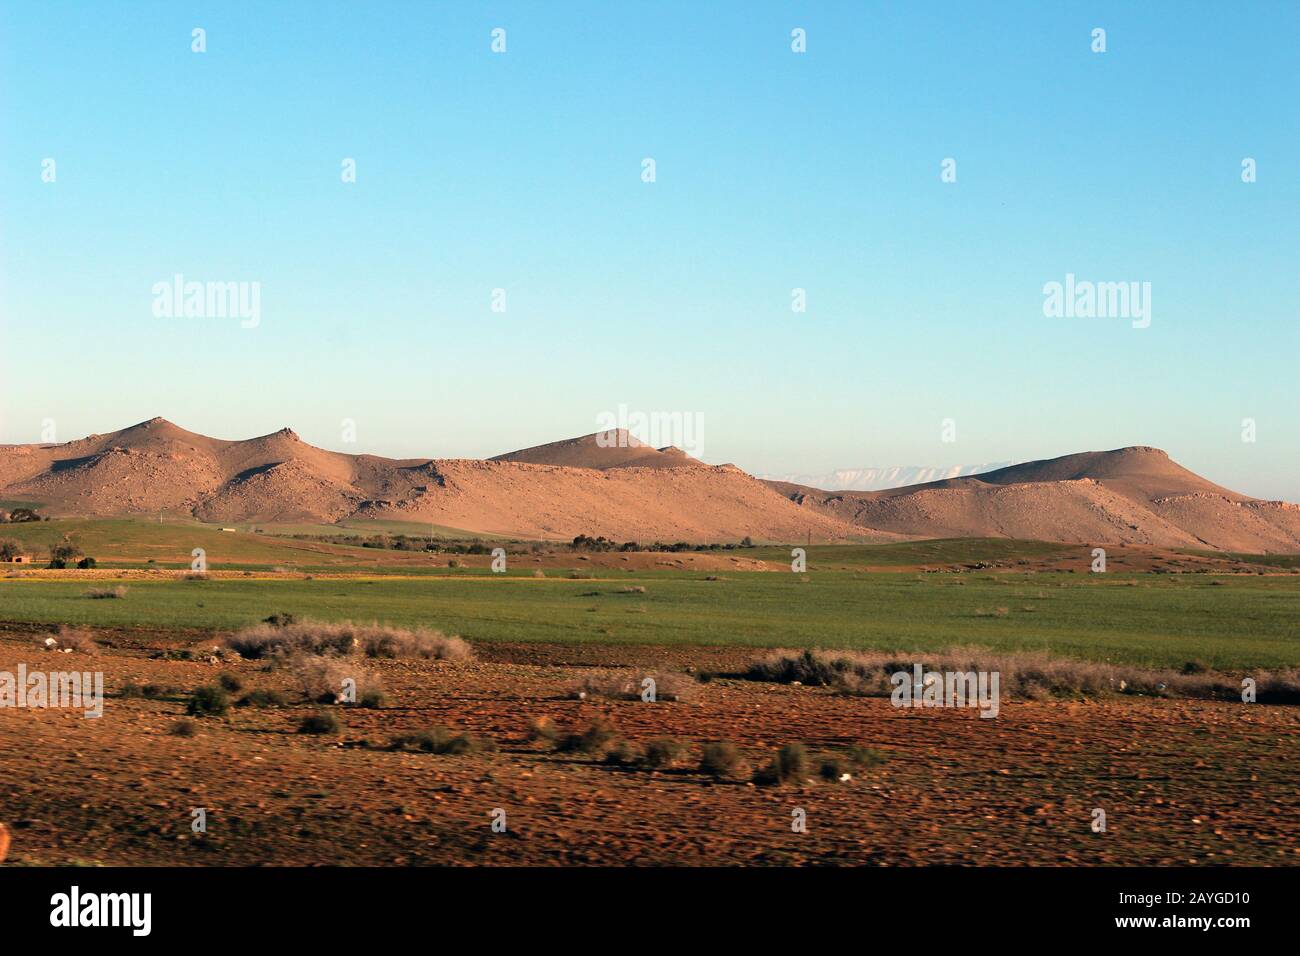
[0,571,1300,667]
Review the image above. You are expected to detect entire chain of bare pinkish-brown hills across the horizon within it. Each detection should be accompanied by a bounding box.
[0,419,1300,553]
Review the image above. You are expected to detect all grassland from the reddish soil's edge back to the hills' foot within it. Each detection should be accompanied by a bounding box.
[0,519,1300,667]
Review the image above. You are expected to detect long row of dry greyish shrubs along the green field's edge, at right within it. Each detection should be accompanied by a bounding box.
[741,648,1300,704]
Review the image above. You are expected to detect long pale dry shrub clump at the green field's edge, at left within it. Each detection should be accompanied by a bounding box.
[226,620,473,661]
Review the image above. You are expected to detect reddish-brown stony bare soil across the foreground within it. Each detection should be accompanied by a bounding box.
[0,626,1300,866]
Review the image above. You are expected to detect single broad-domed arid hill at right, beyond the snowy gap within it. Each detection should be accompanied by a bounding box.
[767,447,1300,553]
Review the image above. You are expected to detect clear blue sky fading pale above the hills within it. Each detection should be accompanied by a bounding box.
[0,0,1300,501]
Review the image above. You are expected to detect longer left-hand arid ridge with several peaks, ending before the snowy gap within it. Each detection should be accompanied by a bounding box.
[0,419,873,541]
